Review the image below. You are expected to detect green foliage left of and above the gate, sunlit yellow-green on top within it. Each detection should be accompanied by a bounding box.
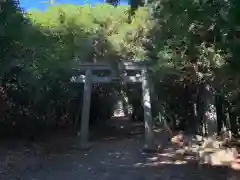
[0,1,148,136]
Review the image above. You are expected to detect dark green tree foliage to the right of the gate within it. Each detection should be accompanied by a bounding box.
[145,0,239,134]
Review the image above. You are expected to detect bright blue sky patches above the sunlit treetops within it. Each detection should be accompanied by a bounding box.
[19,0,127,11]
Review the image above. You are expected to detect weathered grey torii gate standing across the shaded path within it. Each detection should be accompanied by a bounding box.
[71,62,154,150]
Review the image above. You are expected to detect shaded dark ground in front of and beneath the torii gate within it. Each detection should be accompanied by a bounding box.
[0,119,240,180]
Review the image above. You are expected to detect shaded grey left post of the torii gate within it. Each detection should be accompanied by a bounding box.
[80,69,92,149]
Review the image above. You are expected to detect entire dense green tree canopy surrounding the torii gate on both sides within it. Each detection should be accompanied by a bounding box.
[0,0,240,138]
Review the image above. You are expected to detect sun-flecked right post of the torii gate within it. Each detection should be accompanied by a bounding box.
[142,69,155,151]
